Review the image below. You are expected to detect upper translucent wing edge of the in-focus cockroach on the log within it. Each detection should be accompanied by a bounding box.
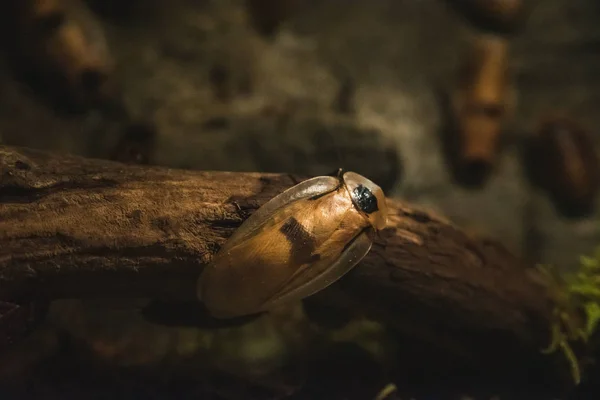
[221,176,340,251]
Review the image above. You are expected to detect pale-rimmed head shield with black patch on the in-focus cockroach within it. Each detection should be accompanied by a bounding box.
[342,172,387,230]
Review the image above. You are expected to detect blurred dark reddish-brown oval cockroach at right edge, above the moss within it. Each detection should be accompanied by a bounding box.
[528,117,600,216]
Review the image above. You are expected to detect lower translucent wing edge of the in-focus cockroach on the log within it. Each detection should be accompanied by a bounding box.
[263,229,373,310]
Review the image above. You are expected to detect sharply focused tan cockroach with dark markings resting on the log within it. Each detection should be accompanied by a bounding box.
[198,169,387,318]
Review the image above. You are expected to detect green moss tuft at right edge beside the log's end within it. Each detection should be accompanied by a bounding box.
[539,247,600,384]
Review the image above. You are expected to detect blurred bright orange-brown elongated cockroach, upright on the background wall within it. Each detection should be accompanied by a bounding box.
[454,36,511,184]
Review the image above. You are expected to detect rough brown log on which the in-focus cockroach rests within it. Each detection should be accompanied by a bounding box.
[0,147,566,392]
